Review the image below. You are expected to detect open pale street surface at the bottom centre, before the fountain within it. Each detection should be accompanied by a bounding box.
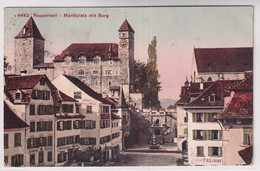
[108,152,182,166]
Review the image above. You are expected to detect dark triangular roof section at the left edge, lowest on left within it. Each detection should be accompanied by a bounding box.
[4,102,30,130]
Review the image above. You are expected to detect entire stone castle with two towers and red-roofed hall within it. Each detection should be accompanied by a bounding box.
[14,17,135,102]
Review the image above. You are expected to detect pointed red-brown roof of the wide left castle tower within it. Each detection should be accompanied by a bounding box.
[15,17,44,40]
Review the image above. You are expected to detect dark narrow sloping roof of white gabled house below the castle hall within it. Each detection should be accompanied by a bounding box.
[63,74,114,106]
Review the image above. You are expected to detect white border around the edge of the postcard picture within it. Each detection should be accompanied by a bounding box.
[0,0,260,171]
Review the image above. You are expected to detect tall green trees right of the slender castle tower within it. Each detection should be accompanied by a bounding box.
[135,37,161,108]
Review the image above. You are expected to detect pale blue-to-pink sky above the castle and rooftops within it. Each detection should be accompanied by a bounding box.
[4,6,253,99]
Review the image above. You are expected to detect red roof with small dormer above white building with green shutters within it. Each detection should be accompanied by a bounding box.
[186,80,240,107]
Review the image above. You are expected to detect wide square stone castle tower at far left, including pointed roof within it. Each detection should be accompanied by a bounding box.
[14,17,44,74]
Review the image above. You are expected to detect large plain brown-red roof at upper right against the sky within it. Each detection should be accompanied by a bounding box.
[194,47,253,73]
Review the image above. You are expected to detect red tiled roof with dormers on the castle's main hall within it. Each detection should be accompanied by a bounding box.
[53,43,118,62]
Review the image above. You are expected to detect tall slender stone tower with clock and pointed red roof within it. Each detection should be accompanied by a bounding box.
[118,19,135,91]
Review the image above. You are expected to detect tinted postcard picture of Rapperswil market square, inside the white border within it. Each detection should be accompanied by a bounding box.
[1,6,254,167]
